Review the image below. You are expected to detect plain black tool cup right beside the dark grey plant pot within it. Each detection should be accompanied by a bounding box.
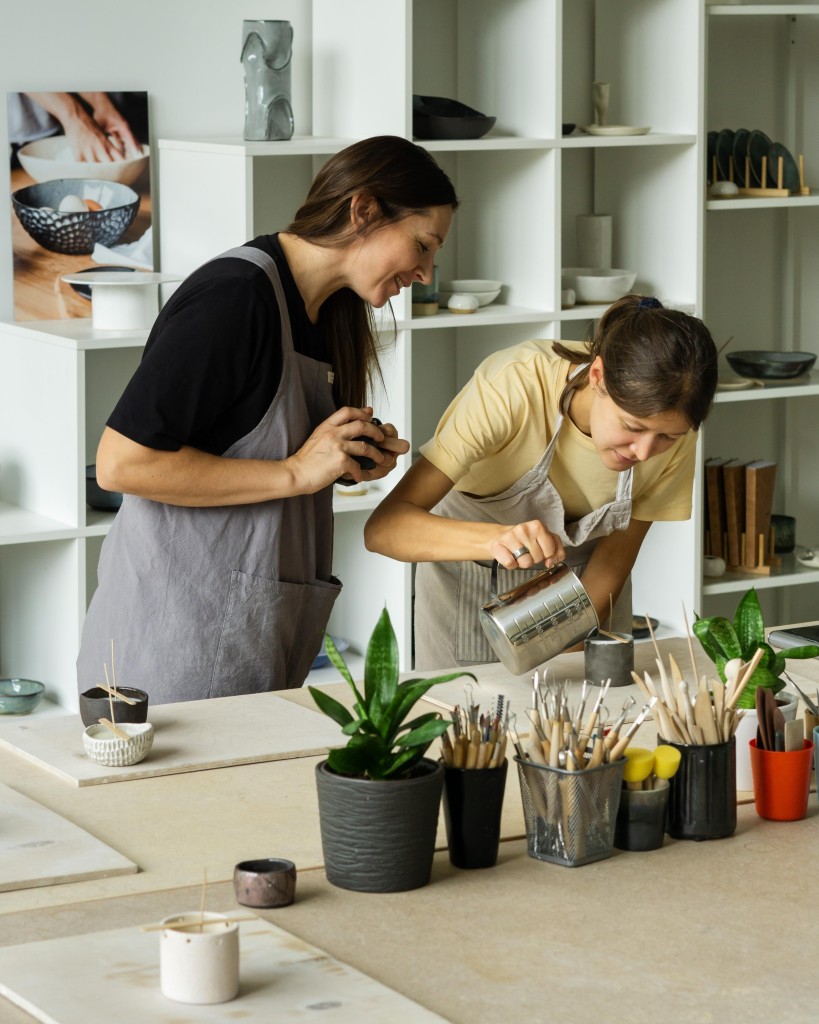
[443,760,508,867]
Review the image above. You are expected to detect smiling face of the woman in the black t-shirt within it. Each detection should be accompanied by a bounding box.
[349,200,452,308]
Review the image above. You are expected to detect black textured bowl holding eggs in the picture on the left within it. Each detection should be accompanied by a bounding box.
[11,178,139,256]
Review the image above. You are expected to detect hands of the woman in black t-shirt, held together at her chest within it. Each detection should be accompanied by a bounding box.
[285,406,410,495]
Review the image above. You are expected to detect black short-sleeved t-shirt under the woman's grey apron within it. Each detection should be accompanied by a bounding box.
[107,234,330,455]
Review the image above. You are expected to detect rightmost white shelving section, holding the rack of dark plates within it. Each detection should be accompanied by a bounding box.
[696,3,819,622]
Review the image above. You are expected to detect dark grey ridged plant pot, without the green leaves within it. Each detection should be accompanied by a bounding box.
[315,758,443,893]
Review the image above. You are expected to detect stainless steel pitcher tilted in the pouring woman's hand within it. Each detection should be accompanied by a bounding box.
[480,562,598,676]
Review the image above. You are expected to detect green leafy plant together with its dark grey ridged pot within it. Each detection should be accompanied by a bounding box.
[309,608,475,892]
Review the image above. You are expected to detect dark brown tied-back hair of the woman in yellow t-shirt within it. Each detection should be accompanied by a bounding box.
[553,295,718,430]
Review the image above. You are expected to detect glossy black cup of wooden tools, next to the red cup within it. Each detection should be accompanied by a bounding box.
[657,736,736,841]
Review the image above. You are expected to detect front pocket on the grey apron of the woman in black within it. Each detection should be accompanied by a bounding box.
[210,570,341,697]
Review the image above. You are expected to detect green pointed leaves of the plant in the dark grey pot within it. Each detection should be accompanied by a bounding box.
[309,608,475,779]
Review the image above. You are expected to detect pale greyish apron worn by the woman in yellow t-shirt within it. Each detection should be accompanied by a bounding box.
[415,367,633,671]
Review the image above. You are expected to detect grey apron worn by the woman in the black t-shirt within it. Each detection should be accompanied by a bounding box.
[77,246,341,703]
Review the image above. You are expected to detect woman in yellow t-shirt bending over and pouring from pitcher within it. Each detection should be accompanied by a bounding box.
[364,295,717,669]
